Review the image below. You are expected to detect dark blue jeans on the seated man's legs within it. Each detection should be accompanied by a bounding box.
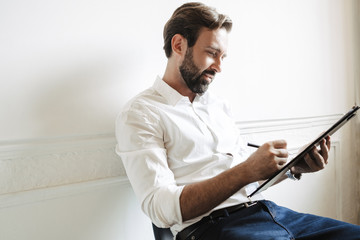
[200,201,360,240]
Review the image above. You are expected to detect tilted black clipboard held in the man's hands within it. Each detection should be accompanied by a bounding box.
[248,106,360,199]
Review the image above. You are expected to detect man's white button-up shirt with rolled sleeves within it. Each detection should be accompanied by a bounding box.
[116,77,263,235]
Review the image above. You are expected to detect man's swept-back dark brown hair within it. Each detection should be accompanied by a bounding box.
[164,2,232,58]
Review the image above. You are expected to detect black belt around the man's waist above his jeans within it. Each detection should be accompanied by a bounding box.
[176,202,257,240]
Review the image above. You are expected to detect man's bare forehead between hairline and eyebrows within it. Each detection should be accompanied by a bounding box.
[194,28,229,52]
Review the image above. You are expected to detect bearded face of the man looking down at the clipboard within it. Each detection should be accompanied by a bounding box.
[179,28,228,94]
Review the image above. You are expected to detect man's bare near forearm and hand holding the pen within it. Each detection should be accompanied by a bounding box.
[180,140,288,221]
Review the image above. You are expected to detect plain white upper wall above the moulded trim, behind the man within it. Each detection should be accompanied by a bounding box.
[0,0,356,141]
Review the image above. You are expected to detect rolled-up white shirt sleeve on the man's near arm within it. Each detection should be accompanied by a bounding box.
[116,102,183,228]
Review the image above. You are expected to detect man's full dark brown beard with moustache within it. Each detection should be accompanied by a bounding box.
[179,48,216,94]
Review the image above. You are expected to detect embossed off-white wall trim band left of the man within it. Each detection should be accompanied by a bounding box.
[0,135,126,195]
